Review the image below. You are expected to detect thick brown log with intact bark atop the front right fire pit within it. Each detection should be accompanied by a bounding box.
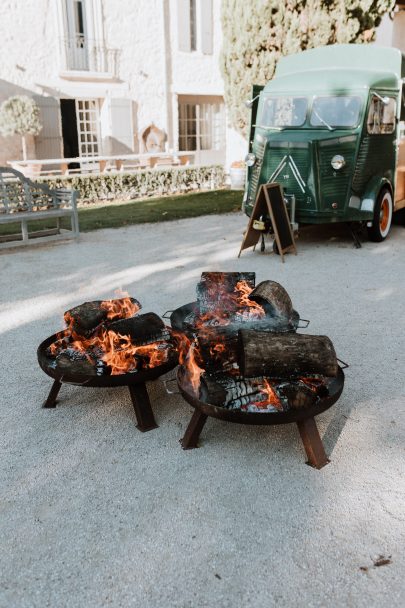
[238,329,338,378]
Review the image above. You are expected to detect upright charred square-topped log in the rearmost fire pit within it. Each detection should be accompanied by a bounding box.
[197,272,256,315]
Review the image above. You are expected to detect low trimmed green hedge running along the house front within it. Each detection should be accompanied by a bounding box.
[38,165,225,202]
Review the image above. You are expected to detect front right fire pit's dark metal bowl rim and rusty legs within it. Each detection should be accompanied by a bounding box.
[177,366,344,469]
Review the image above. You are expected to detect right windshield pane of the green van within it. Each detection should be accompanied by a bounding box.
[310,95,362,128]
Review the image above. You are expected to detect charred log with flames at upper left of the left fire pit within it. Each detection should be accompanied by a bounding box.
[64,298,141,337]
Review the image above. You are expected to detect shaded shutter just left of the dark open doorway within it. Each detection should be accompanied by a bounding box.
[34,95,63,158]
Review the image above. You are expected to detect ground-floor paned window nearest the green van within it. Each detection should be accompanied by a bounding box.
[179,96,225,152]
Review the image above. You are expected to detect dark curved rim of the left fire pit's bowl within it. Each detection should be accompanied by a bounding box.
[37,334,178,387]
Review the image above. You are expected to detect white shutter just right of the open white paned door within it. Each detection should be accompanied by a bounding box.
[100,97,134,154]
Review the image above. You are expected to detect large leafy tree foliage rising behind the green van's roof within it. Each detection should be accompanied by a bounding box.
[221,0,395,134]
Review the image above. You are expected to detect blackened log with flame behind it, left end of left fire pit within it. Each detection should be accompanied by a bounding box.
[64,298,141,337]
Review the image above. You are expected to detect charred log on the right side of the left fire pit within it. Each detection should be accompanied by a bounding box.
[104,312,171,345]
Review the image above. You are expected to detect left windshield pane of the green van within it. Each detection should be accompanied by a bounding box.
[260,96,308,127]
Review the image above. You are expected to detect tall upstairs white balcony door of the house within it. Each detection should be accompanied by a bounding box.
[66,0,89,70]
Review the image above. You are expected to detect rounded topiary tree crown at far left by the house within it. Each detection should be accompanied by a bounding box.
[0,95,42,136]
